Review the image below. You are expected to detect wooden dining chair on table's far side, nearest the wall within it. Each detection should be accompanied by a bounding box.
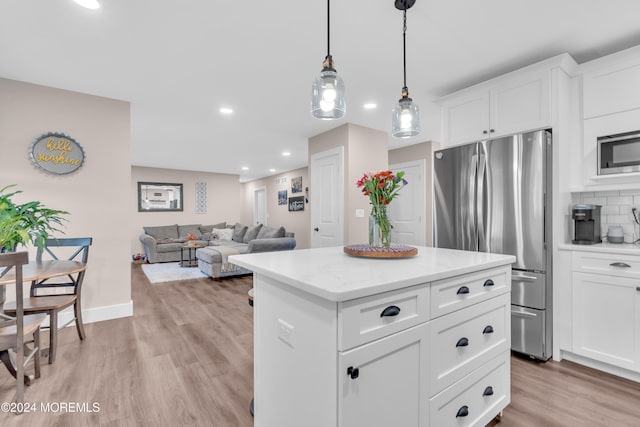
[4,237,93,363]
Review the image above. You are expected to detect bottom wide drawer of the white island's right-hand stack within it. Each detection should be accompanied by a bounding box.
[429,351,511,427]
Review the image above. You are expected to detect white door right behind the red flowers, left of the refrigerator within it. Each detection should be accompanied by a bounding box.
[389,160,427,246]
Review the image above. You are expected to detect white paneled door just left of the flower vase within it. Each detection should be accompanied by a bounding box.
[309,147,344,248]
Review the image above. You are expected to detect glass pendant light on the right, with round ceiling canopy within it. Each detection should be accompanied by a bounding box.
[391,0,420,138]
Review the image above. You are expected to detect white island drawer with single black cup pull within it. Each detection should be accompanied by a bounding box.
[338,284,429,351]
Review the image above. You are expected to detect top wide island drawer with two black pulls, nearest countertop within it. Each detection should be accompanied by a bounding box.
[431,266,511,318]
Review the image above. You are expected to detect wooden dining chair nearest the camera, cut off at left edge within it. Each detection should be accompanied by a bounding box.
[0,252,47,409]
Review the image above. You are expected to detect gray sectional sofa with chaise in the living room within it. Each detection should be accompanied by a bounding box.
[140,223,296,278]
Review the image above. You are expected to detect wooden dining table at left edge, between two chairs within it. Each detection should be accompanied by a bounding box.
[0,260,87,385]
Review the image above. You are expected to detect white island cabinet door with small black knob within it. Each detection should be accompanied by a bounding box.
[338,323,429,427]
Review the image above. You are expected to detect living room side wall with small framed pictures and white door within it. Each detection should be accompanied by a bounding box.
[239,168,311,249]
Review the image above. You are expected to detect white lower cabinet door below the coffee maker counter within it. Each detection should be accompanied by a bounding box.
[573,272,640,372]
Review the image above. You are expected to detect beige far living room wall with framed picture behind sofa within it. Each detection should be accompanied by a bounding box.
[127,166,243,255]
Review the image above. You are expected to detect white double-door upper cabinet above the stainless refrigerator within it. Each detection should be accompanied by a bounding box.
[440,70,551,146]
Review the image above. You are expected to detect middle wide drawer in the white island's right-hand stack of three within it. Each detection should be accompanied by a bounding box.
[429,293,511,394]
